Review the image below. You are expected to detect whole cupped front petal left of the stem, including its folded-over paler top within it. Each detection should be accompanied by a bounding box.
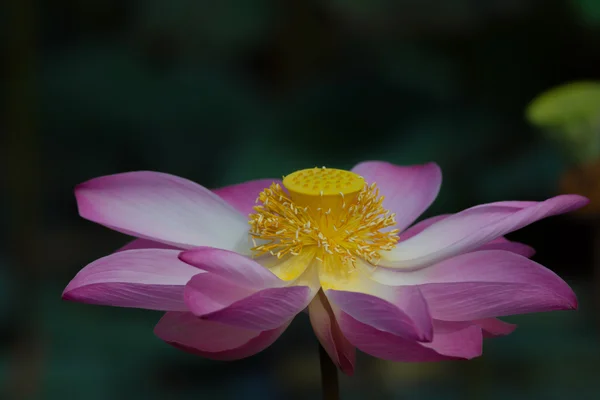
[180,248,316,330]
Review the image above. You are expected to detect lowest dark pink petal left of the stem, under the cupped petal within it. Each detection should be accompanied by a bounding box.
[154,312,289,360]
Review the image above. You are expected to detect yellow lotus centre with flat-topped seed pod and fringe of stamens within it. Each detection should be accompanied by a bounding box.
[249,167,398,279]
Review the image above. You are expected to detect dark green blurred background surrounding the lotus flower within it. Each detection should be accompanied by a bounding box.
[0,0,600,400]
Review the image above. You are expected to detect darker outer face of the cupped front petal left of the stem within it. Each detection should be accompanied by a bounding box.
[184,274,314,330]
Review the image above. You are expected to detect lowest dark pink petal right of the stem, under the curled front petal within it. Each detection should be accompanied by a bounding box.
[336,311,482,362]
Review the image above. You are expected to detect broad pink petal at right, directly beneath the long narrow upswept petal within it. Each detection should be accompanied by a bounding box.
[372,250,577,321]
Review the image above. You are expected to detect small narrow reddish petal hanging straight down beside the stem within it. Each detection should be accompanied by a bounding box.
[308,292,356,376]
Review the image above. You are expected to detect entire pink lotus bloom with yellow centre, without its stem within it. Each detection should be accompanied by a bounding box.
[63,161,587,374]
